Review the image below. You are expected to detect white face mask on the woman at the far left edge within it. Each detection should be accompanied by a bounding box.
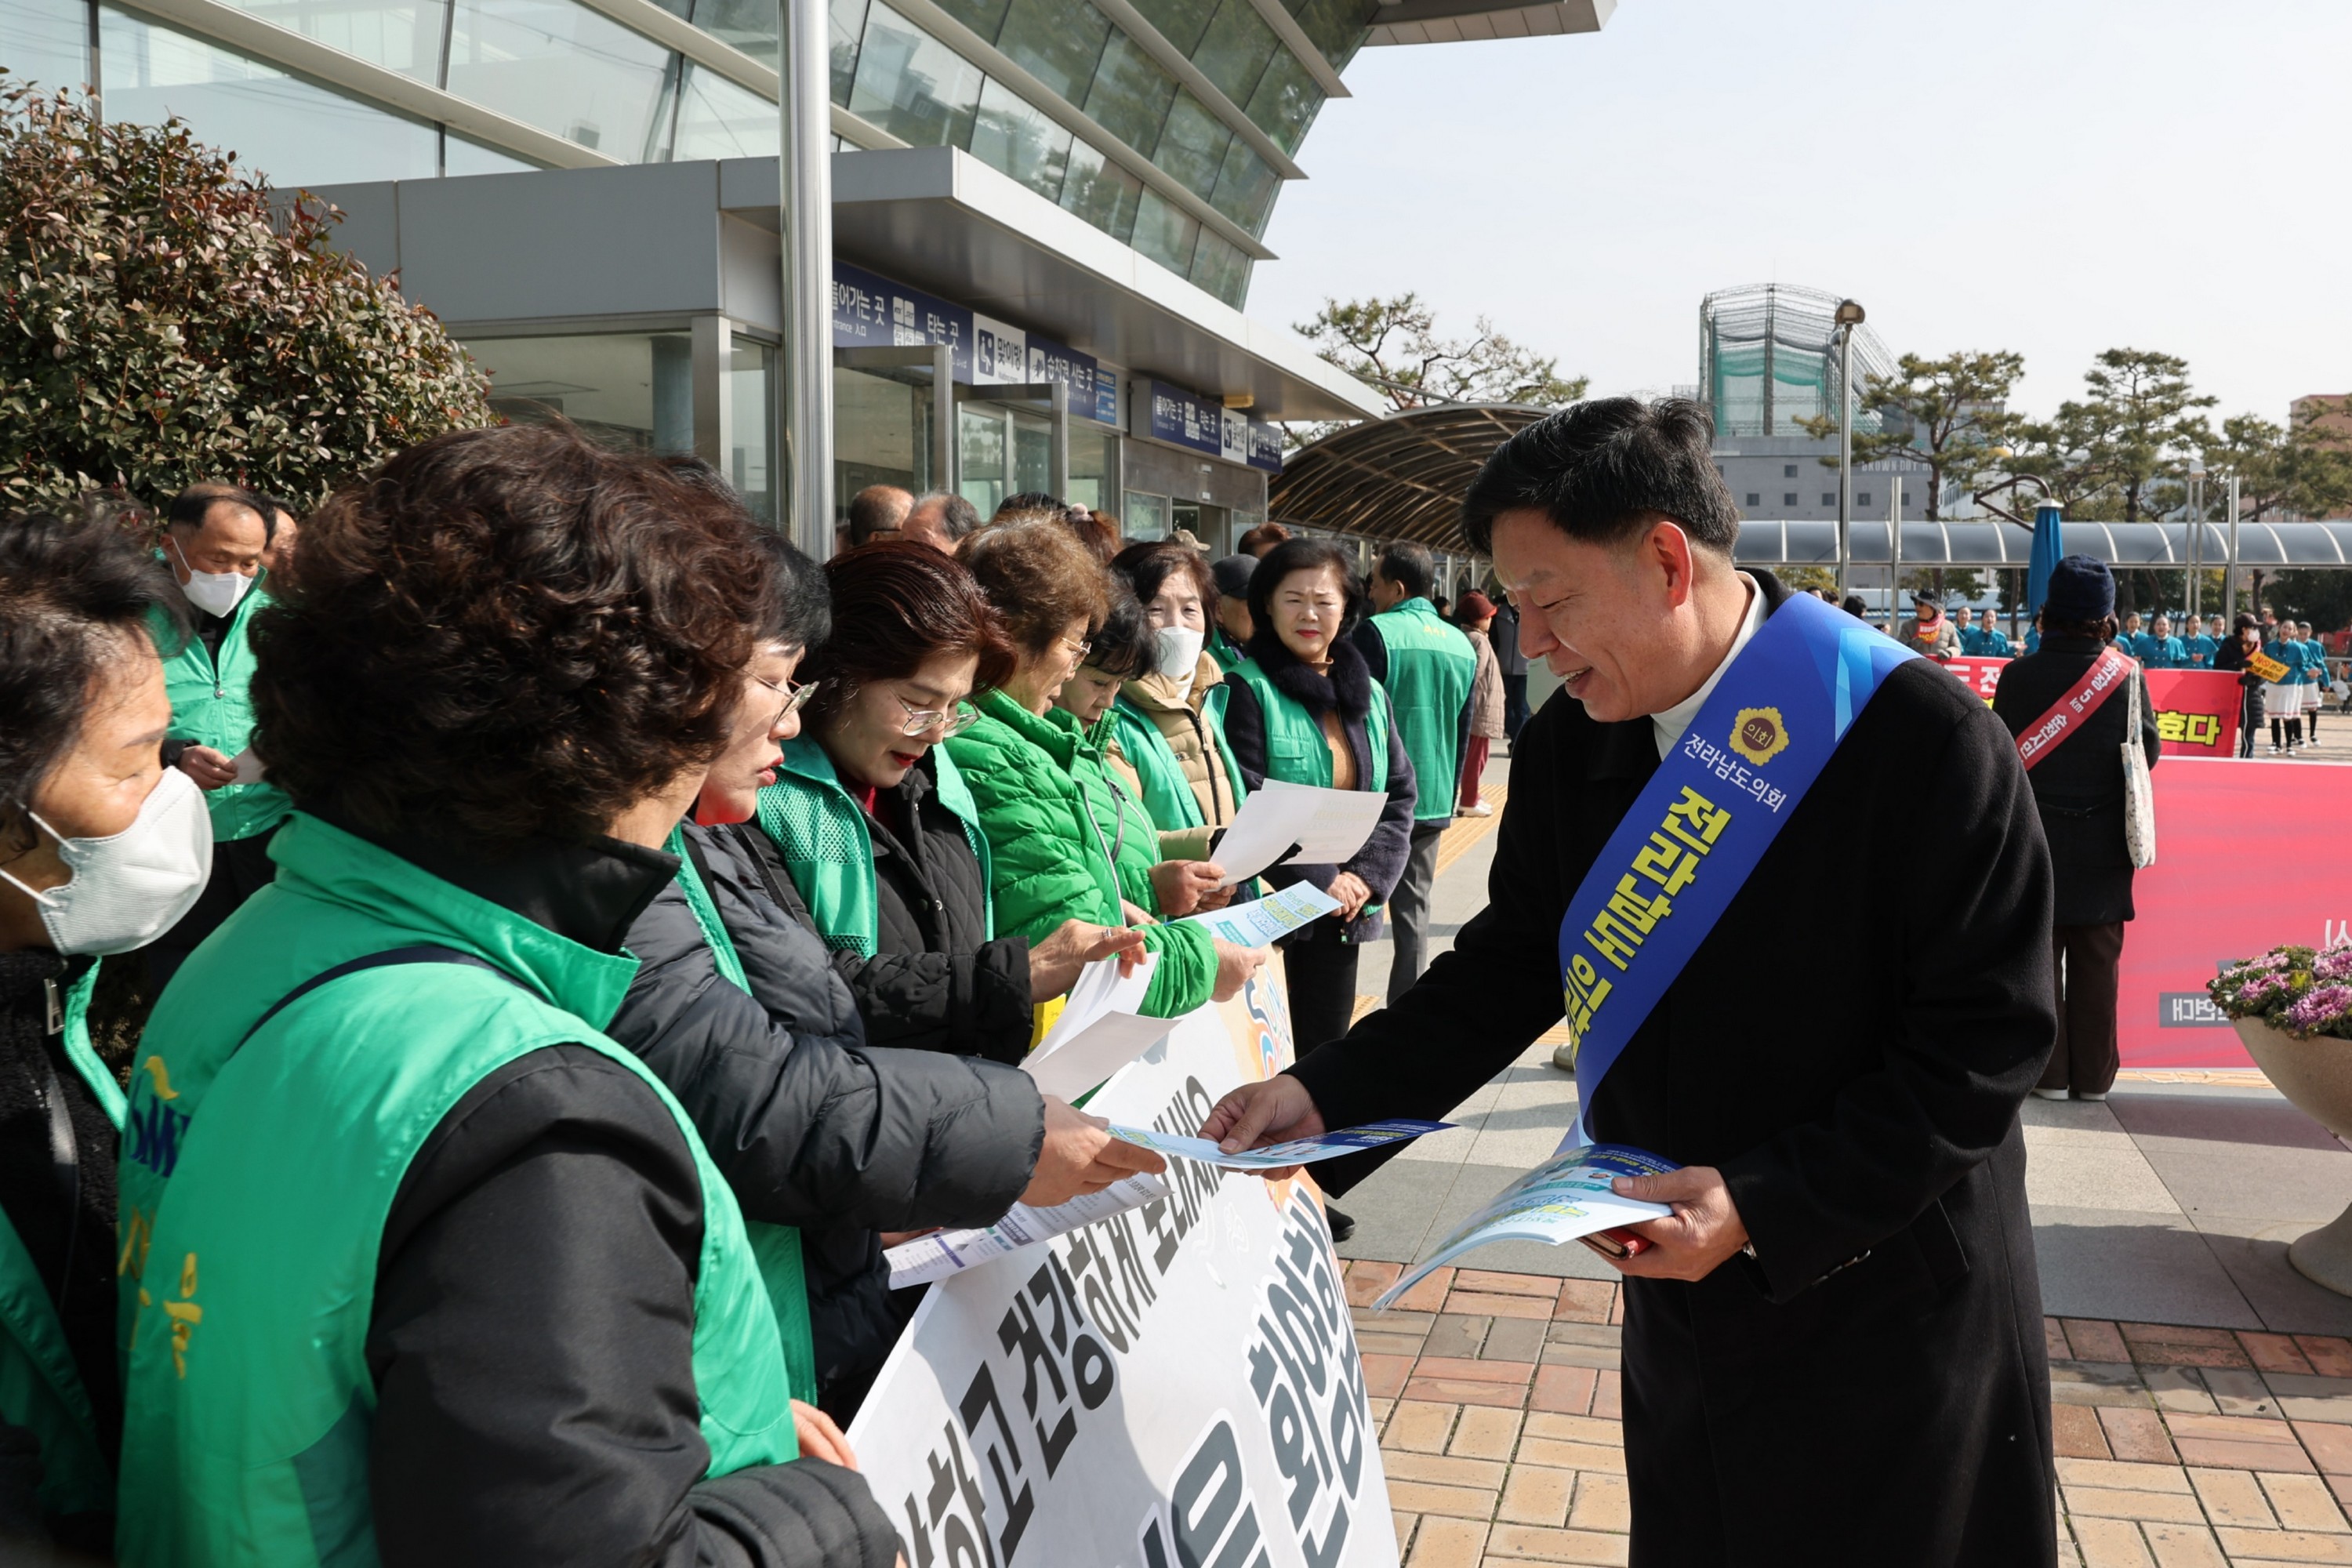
[0,769,212,954]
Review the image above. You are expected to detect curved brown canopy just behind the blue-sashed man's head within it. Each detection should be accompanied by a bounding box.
[1265,402,1550,550]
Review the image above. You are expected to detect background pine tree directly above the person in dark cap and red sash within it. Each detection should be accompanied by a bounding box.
[2009,348,2220,522]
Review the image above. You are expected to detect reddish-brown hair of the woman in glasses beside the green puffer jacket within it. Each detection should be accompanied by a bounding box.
[800,539,1014,724]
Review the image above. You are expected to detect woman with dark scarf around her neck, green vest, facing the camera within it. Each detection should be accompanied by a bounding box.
[1225,539,1416,1055]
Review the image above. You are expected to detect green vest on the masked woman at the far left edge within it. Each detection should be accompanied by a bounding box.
[0,964,122,1516]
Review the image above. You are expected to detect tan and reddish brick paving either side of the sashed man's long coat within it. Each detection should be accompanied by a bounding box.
[1348,1262,2352,1568]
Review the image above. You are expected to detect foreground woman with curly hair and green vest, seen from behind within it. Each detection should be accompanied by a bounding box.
[115,426,896,1568]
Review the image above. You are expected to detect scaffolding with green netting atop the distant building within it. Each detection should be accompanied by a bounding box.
[1698,282,1896,440]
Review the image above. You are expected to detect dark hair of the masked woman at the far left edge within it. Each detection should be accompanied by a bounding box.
[0,496,183,841]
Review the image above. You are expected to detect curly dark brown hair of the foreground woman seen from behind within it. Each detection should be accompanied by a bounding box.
[252,423,776,846]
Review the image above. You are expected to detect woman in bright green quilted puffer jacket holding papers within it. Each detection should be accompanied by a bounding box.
[946,520,1265,1018]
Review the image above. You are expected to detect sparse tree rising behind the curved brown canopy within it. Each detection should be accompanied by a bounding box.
[1284,294,1592,445]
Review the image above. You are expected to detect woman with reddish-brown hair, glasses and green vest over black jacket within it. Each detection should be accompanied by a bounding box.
[753,541,1143,1062]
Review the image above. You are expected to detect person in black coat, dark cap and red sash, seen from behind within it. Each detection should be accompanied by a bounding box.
[1992,555,2161,1100]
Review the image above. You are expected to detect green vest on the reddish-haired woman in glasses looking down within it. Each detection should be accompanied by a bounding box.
[757,739,997,959]
